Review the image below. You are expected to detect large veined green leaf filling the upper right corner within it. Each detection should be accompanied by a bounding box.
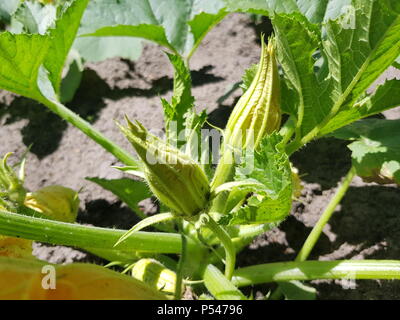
[272,0,400,146]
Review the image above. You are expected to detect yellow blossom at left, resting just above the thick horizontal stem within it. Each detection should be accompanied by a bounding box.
[24,185,79,222]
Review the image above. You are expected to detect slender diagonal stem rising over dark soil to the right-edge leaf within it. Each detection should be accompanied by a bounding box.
[296,167,356,261]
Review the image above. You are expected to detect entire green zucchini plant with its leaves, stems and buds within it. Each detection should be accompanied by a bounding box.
[0,0,400,299]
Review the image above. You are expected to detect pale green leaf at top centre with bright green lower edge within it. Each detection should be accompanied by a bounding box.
[80,0,225,56]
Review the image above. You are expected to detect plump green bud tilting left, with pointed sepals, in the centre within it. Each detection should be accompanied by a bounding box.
[120,119,210,219]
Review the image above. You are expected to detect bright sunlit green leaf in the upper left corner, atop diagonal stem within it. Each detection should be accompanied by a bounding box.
[0,0,88,101]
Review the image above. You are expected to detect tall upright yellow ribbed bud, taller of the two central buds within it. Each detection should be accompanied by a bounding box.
[212,39,282,189]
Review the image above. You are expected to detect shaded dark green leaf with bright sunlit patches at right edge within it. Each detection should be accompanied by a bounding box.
[334,119,400,185]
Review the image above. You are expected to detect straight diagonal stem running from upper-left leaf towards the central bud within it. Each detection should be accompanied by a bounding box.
[41,99,137,166]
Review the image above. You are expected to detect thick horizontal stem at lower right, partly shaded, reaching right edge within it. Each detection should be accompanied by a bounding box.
[232,260,400,287]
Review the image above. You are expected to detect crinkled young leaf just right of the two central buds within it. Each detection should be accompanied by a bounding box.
[219,134,292,225]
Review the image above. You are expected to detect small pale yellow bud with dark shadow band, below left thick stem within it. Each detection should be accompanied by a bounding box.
[132,259,176,294]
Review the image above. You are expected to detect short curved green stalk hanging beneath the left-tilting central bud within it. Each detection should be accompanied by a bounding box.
[205,216,236,280]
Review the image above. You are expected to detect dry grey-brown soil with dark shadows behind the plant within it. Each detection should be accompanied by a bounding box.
[0,14,400,299]
